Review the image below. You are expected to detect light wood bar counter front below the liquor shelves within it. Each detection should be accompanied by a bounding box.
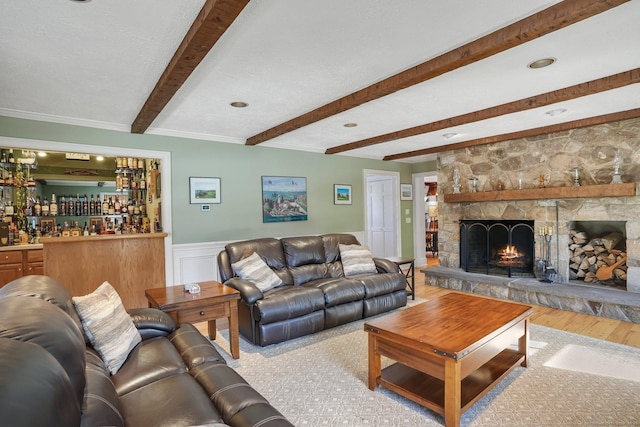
[40,233,167,308]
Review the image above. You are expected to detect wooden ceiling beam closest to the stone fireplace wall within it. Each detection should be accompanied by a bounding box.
[383,108,640,160]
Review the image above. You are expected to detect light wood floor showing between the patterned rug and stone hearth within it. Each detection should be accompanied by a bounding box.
[415,257,640,348]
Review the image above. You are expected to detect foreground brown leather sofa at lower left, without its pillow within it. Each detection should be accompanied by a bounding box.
[0,276,293,427]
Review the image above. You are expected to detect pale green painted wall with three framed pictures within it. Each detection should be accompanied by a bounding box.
[0,116,435,256]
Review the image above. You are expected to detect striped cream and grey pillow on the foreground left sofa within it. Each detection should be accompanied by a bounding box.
[73,282,142,375]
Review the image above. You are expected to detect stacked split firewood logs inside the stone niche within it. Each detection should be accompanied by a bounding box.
[569,230,627,286]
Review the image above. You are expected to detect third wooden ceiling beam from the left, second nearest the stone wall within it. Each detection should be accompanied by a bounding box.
[325,68,640,154]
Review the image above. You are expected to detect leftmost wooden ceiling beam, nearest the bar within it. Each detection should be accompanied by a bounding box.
[131,0,249,133]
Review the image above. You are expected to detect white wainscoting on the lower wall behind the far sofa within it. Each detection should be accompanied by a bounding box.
[167,231,365,286]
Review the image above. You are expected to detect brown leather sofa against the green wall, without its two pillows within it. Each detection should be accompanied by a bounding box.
[218,234,407,346]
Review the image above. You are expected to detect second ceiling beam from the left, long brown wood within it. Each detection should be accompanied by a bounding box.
[246,0,629,145]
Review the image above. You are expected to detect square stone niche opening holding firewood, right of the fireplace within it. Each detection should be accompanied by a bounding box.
[569,221,627,290]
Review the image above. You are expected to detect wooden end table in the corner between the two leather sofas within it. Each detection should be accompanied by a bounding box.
[144,281,240,359]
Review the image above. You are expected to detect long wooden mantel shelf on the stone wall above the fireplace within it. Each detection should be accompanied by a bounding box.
[444,182,636,203]
